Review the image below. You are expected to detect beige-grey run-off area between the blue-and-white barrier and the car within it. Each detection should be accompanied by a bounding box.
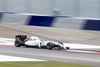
[0,24,100,45]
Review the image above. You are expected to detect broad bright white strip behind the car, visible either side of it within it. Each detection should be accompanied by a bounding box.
[0,38,100,49]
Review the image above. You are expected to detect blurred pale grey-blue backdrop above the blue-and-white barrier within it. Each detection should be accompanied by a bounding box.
[0,0,100,18]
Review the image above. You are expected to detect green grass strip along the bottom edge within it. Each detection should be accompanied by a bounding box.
[0,61,92,67]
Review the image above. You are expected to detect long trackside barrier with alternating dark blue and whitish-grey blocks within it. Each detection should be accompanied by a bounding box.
[0,13,100,31]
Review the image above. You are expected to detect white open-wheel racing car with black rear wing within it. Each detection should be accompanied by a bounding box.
[14,35,69,50]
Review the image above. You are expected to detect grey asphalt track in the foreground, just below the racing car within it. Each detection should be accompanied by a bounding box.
[0,46,100,67]
